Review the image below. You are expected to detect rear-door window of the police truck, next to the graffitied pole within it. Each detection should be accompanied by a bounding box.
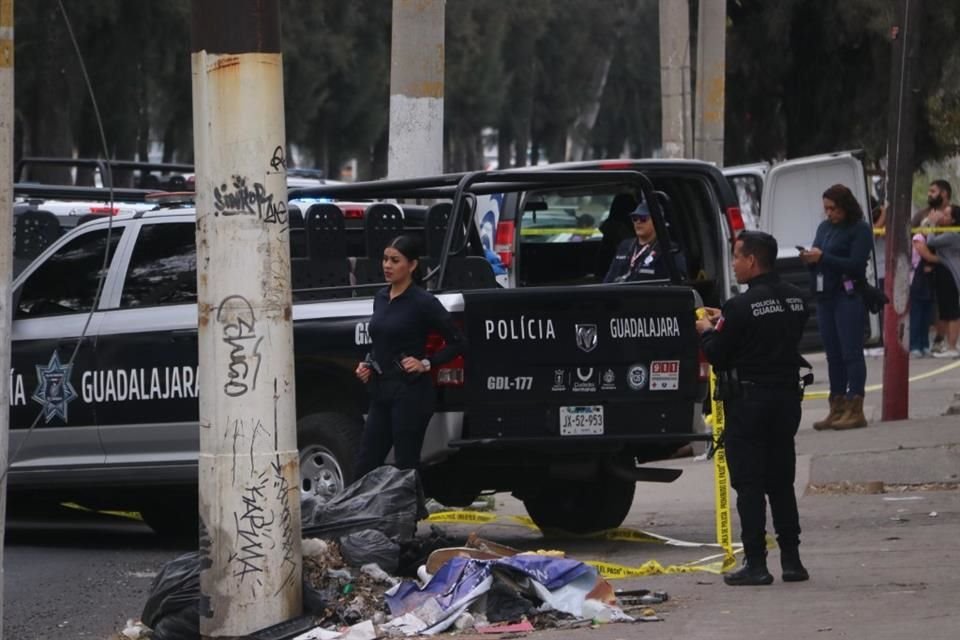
[120,222,197,308]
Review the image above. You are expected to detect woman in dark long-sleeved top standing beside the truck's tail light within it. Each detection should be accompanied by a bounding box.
[356,236,463,477]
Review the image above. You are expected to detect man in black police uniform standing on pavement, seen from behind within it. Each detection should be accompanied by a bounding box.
[697,231,810,585]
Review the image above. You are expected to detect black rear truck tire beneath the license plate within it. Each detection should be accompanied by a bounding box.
[523,475,636,533]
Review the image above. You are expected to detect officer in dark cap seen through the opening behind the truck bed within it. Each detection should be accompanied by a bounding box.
[603,202,687,282]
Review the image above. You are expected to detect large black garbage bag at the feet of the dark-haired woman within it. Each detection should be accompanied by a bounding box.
[300,466,427,544]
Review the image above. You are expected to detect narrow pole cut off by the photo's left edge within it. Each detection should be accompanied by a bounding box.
[0,0,14,639]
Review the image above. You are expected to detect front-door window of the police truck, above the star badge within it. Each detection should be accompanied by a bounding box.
[14,227,123,320]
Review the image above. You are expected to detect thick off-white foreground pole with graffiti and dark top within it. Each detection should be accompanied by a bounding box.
[191,0,302,638]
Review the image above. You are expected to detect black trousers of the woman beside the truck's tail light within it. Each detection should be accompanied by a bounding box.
[356,376,434,478]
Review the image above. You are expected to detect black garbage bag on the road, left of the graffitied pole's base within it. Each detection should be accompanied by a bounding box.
[140,551,200,640]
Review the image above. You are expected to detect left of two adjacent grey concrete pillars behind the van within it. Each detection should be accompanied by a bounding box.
[660,0,693,158]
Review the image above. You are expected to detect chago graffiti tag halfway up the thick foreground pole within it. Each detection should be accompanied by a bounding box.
[217,296,263,397]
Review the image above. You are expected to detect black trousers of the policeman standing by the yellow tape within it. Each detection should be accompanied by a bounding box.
[724,385,801,559]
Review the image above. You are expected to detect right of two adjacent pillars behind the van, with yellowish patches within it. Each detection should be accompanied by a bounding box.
[694,0,727,167]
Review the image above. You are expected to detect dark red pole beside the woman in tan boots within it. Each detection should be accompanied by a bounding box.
[882,0,923,420]
